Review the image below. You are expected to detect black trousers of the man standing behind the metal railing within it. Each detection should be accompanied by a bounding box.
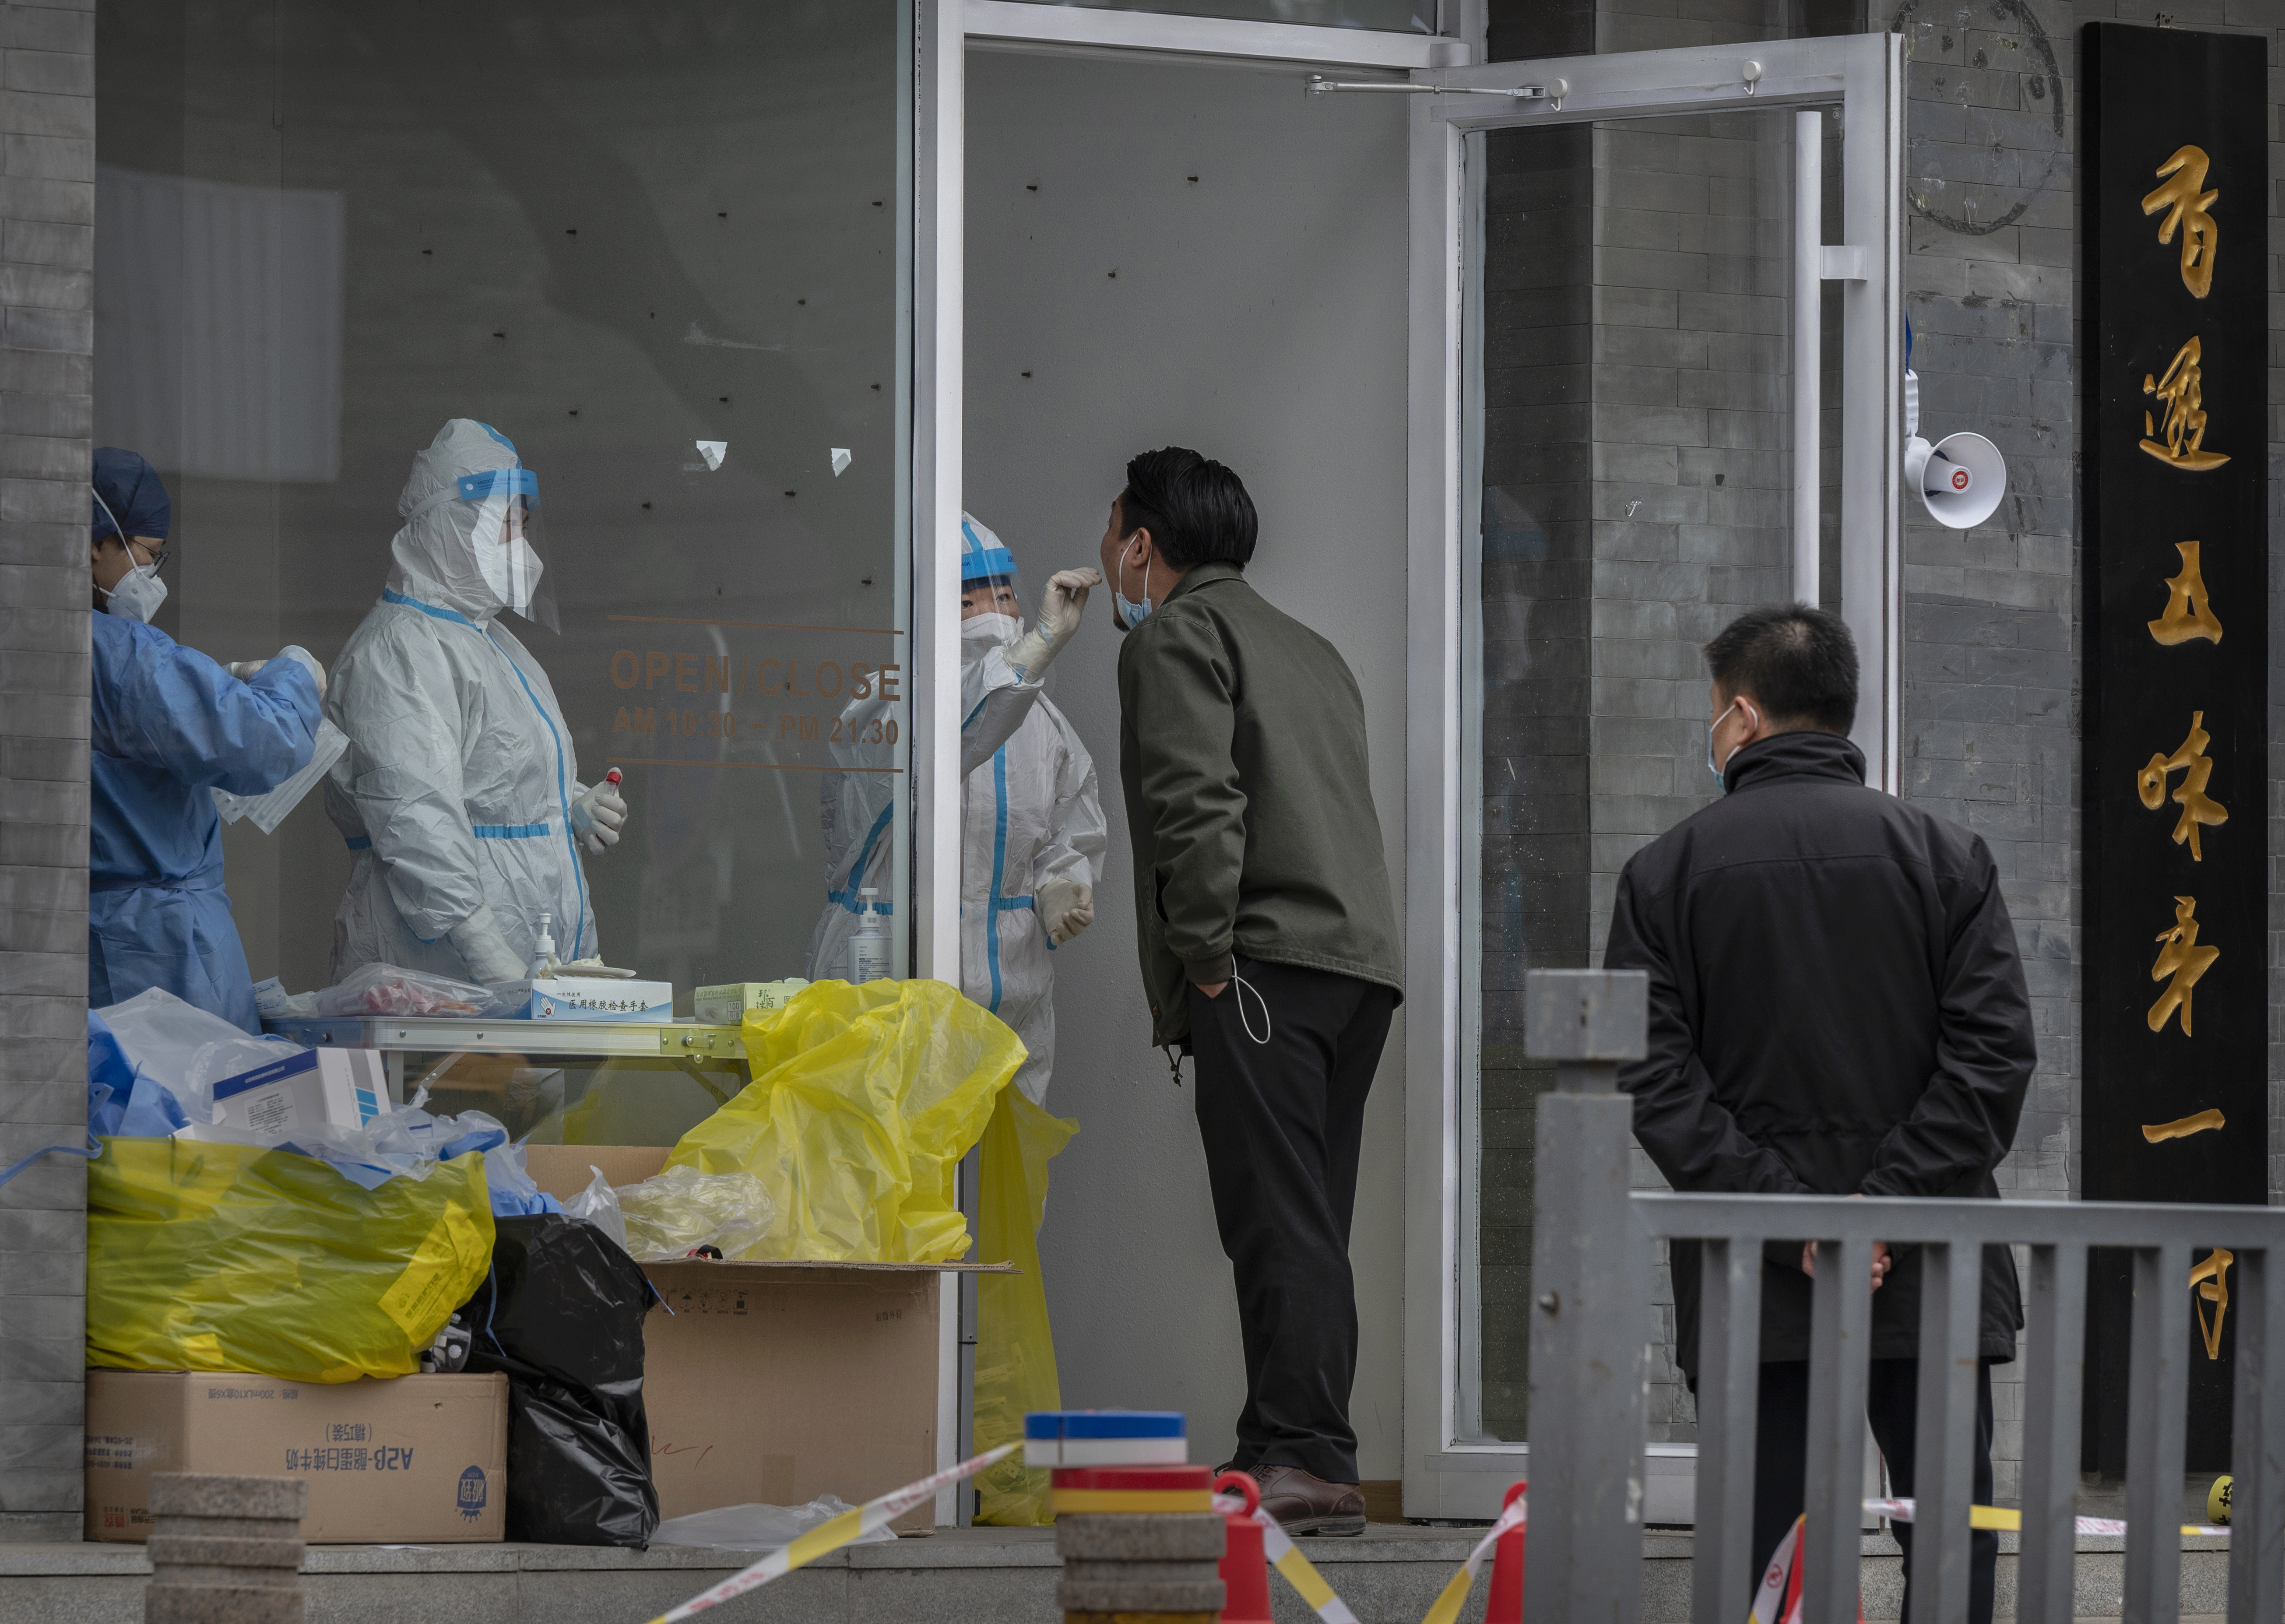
[1746,1359,2000,1624]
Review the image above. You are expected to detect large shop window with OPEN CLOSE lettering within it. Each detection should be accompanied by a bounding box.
[96,0,912,1009]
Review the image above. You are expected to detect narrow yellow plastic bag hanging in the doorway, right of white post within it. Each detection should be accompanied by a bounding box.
[976,1087,1079,1528]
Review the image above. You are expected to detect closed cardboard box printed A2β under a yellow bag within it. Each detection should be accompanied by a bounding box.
[84,1371,507,1544]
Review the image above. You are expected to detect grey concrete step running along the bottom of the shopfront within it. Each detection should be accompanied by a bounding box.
[0,1523,2230,1624]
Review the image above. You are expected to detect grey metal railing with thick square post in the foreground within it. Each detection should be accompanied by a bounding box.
[1524,971,2285,1624]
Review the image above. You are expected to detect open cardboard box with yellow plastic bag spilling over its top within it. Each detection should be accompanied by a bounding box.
[526,1144,944,1530]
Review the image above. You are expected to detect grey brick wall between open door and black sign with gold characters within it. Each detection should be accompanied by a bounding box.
[1869,0,2084,1501]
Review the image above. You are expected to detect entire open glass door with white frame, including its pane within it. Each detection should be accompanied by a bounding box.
[1405,36,1901,1523]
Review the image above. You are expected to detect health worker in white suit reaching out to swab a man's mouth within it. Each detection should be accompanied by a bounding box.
[809,514,1106,1106]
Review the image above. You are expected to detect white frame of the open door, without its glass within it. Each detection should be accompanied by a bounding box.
[1403,34,1903,1521]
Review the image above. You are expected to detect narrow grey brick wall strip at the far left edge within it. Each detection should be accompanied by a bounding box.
[0,4,96,1540]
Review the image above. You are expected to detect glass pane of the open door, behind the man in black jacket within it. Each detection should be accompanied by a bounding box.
[1460,109,1839,1444]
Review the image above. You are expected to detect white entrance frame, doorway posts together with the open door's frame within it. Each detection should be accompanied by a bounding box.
[910,0,1903,1523]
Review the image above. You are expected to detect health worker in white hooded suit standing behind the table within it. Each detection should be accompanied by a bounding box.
[324,418,626,984]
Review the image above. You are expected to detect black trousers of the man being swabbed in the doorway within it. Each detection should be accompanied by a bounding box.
[1191,955,1396,1482]
